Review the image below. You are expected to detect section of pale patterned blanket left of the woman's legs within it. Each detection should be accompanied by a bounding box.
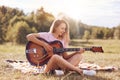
[6,60,45,74]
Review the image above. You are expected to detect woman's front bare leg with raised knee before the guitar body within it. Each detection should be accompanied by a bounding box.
[45,55,82,74]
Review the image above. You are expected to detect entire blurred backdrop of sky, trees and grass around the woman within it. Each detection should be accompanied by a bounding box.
[0,0,120,80]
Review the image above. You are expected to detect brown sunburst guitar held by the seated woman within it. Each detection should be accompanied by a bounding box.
[25,38,103,66]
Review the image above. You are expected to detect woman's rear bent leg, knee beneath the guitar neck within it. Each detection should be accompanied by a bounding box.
[67,52,83,66]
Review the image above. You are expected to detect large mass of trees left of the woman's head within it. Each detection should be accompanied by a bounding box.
[0,6,54,44]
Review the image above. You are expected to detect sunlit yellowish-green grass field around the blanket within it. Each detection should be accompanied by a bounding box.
[0,40,120,80]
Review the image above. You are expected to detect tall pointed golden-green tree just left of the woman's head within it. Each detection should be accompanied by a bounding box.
[34,7,54,32]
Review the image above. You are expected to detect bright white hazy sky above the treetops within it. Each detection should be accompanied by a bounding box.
[0,0,120,27]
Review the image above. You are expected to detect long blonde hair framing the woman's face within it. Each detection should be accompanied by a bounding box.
[49,20,70,46]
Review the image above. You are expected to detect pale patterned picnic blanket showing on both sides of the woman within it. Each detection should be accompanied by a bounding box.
[6,60,118,74]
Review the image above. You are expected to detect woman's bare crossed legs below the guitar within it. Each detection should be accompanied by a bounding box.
[45,54,82,74]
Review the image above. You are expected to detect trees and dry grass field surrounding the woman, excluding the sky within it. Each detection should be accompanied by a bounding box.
[0,0,120,80]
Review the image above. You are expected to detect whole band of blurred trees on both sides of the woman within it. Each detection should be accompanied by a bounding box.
[0,6,120,44]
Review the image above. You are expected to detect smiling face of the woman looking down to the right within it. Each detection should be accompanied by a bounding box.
[55,23,66,36]
